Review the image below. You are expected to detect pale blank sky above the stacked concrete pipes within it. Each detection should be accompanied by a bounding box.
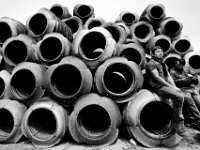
[0,0,200,51]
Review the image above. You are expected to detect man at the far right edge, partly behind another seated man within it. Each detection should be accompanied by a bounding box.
[170,59,200,130]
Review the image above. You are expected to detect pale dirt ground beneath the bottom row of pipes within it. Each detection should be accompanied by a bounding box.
[0,128,200,150]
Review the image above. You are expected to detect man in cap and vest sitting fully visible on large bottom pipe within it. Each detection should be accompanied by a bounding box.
[145,46,186,136]
